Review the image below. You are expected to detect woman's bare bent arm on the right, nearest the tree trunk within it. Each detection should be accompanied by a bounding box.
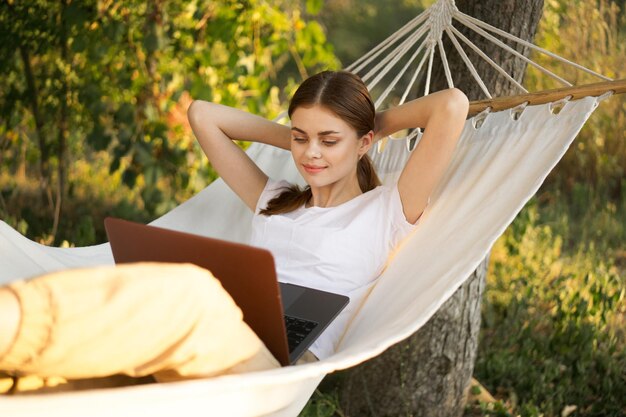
[375,88,469,223]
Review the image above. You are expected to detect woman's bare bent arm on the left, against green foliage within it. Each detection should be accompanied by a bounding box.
[187,100,291,211]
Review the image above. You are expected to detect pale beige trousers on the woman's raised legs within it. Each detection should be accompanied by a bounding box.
[0,263,279,392]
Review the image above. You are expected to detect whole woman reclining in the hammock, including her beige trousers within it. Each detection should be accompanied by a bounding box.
[0,71,468,391]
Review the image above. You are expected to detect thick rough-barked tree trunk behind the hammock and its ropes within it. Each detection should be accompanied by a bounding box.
[340,0,543,417]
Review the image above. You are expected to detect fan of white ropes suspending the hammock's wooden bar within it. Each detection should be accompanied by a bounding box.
[347,0,623,148]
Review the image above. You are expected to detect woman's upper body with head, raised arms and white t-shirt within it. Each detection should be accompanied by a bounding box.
[188,71,468,359]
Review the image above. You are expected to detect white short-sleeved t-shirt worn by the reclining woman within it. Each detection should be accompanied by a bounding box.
[250,178,416,359]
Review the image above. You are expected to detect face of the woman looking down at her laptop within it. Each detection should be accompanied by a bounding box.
[291,105,369,187]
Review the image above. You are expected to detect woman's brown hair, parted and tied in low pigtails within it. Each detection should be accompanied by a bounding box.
[260,71,381,216]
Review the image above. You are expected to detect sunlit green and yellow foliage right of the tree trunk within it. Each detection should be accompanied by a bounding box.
[468,0,626,416]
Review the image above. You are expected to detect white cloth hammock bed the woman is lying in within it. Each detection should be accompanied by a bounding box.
[0,0,616,417]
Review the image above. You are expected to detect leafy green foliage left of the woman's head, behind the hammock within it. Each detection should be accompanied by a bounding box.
[0,0,338,245]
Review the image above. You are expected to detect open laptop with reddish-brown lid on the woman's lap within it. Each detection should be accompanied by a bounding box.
[104,217,349,366]
